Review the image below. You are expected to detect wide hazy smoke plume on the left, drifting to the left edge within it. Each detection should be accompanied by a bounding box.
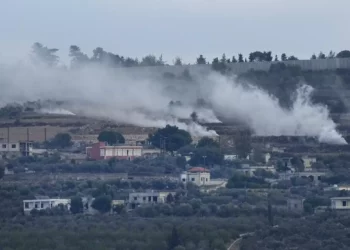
[0,63,218,136]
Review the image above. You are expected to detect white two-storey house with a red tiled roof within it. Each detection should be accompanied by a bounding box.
[180,167,210,186]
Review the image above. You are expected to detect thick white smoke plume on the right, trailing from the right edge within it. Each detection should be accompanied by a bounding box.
[207,75,347,144]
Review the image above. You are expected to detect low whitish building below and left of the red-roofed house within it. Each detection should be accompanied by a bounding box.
[129,191,176,209]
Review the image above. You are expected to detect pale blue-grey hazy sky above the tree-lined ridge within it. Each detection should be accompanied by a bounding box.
[0,0,350,63]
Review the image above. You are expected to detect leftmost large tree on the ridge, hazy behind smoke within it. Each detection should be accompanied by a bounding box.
[32,42,59,67]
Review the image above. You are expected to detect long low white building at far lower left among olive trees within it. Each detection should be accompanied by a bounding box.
[23,196,70,214]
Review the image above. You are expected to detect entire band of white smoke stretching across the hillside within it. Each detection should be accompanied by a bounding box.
[0,58,346,144]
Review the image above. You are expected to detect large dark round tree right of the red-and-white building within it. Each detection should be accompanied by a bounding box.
[149,125,192,152]
